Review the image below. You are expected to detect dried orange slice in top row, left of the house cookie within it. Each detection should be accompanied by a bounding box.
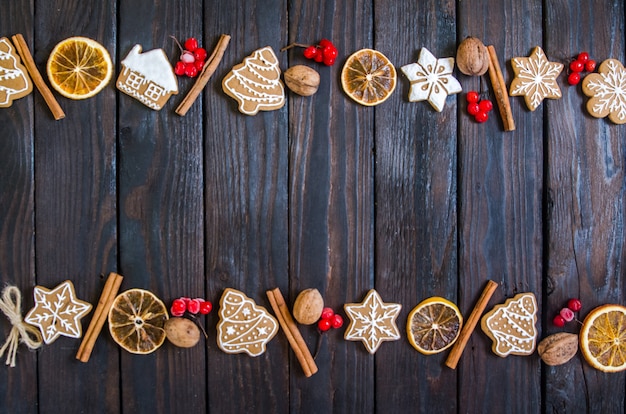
[46,37,113,99]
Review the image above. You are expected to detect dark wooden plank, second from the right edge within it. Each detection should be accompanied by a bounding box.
[457,0,540,413]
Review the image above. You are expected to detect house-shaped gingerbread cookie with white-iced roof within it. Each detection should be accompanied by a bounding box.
[117,45,178,111]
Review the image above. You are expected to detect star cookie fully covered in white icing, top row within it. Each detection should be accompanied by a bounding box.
[400,47,462,112]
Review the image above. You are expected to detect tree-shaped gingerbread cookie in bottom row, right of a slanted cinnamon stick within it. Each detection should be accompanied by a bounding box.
[480,292,537,358]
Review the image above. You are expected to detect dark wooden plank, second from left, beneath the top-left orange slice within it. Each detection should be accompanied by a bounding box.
[33,0,119,412]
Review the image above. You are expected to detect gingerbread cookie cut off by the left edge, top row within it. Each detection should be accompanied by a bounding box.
[0,37,33,108]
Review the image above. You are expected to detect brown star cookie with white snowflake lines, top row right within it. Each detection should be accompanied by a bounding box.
[509,46,563,111]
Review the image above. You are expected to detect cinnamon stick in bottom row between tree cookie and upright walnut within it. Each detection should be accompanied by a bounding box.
[267,288,317,377]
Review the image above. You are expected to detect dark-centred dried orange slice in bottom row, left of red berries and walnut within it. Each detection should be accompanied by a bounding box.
[109,289,169,354]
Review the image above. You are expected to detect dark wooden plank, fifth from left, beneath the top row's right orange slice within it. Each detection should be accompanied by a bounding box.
[289,1,375,413]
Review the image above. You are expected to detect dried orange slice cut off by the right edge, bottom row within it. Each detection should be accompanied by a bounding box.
[580,305,626,372]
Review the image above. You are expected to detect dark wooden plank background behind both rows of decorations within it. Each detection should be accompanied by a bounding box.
[0,0,626,413]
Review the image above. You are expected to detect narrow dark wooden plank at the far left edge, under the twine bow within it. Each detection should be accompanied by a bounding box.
[0,1,37,413]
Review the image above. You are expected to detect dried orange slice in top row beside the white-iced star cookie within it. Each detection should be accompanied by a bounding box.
[341,49,396,106]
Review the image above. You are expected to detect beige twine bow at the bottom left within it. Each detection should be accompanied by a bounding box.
[0,286,42,367]
